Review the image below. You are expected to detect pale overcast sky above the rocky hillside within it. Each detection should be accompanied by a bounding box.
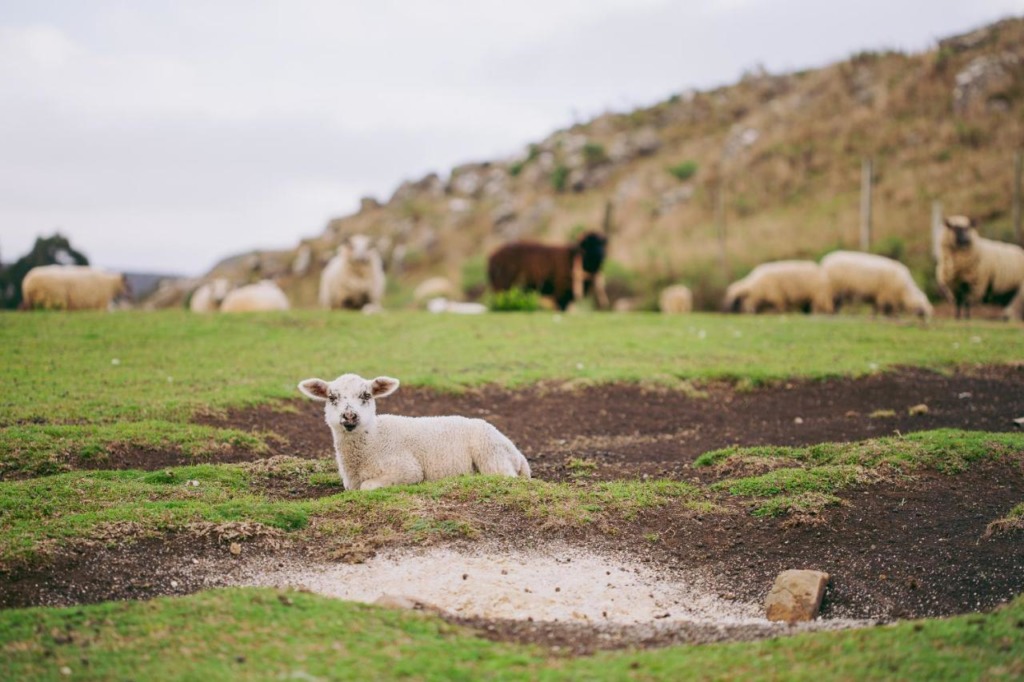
[0,0,1024,275]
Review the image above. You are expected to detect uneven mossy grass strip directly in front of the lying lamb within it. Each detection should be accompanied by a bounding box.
[0,458,714,566]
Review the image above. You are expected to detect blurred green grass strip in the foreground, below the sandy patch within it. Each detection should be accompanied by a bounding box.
[0,590,1024,680]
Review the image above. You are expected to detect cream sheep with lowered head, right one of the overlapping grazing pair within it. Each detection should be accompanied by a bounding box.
[821,251,932,318]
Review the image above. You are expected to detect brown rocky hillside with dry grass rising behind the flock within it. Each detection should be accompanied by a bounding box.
[146,19,1024,306]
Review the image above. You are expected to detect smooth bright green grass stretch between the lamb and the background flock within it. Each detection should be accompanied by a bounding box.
[0,310,1024,427]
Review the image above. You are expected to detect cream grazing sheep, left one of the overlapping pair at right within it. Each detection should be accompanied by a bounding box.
[723,260,835,312]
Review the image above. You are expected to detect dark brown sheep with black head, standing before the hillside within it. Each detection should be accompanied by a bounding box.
[487,232,608,310]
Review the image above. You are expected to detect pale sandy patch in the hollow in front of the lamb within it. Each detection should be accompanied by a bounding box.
[241,545,839,625]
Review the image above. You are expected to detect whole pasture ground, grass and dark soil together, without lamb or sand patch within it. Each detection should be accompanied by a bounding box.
[0,311,1024,679]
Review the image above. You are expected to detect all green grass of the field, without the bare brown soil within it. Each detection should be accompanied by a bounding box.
[0,311,1024,679]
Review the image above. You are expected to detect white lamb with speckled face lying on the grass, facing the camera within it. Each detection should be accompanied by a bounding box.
[299,374,530,491]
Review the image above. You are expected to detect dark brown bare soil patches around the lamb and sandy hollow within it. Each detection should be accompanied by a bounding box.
[0,364,1024,652]
